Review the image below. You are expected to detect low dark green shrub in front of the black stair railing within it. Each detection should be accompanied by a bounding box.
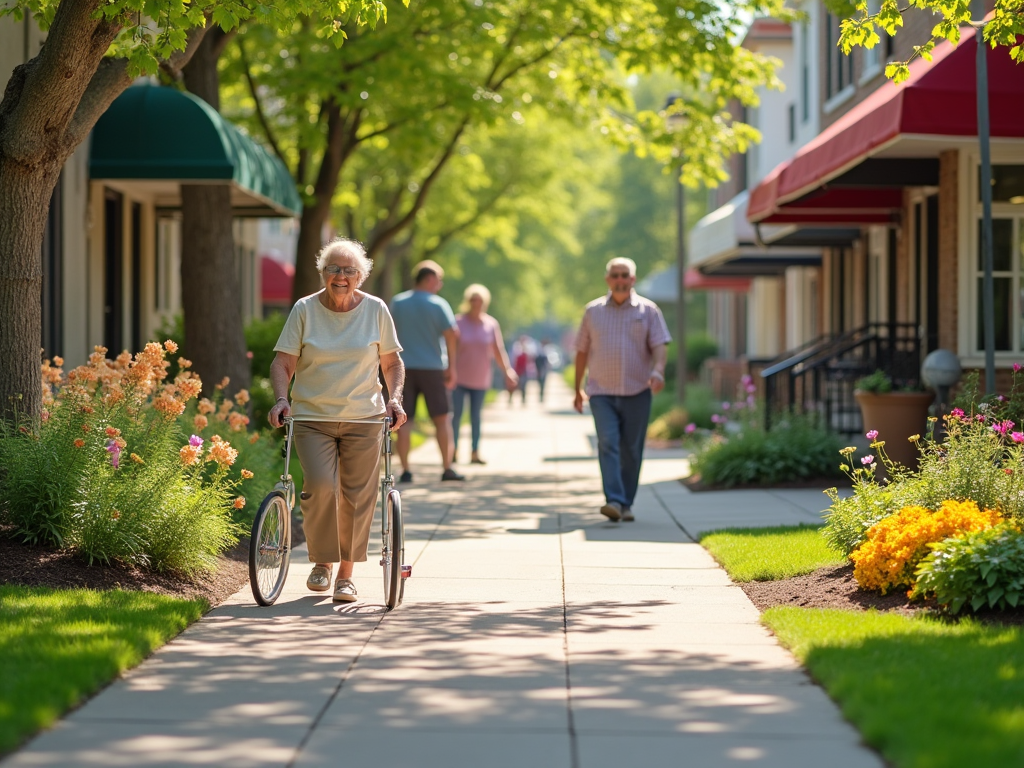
[693,420,841,487]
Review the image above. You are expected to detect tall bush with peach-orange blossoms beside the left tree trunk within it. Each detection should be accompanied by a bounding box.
[0,342,256,573]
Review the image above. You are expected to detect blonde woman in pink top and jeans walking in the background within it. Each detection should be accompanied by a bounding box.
[453,284,517,464]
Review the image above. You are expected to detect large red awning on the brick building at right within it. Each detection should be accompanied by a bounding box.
[746,29,1024,224]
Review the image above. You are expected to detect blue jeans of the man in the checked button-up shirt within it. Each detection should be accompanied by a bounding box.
[590,389,651,507]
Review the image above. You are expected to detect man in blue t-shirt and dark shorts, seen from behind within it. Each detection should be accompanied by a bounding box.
[391,259,466,482]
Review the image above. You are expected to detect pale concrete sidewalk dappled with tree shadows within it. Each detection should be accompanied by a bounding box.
[3,377,883,768]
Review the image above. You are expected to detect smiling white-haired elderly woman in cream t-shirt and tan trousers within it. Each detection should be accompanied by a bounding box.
[268,239,407,603]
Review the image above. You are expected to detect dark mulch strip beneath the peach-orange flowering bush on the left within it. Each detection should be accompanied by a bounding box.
[0,519,304,608]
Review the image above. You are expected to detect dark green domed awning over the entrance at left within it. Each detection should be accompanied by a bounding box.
[89,84,302,216]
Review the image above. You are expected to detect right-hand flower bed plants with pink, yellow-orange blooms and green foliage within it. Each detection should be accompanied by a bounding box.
[823,376,1024,613]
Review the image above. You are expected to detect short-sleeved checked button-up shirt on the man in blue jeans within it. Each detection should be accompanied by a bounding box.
[575,291,672,395]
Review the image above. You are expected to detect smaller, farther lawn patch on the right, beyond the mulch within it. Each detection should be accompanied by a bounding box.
[700,525,846,582]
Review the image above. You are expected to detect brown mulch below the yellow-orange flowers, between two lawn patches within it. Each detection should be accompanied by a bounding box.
[739,565,1024,625]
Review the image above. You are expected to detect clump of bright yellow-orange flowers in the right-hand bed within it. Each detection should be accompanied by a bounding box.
[850,500,1001,594]
